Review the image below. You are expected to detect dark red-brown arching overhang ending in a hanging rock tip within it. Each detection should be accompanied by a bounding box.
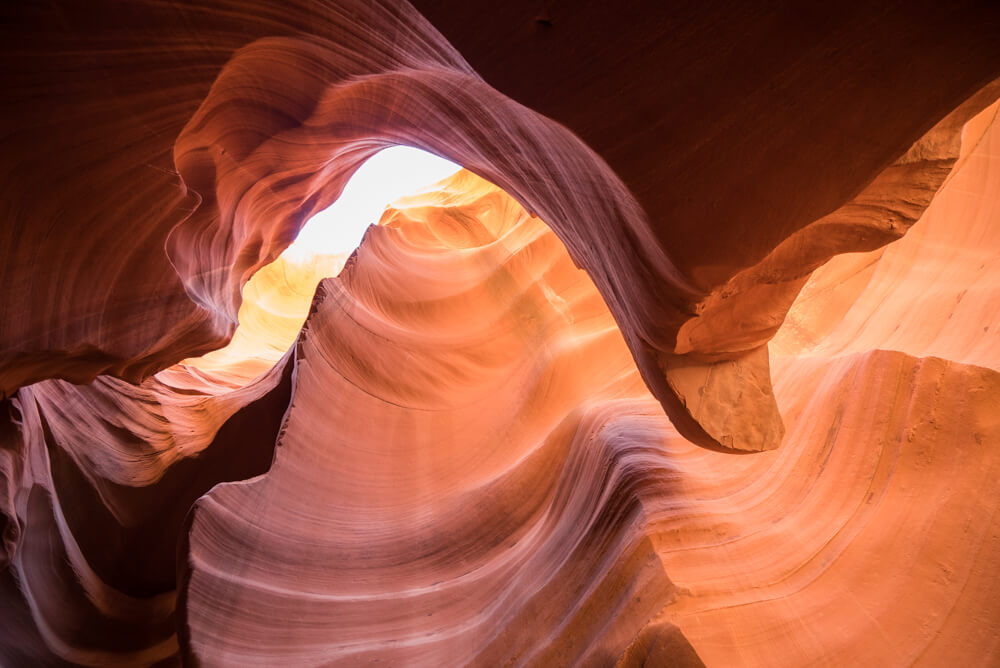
[7,0,1000,450]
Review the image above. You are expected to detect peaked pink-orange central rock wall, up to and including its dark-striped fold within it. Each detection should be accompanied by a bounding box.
[184,173,671,665]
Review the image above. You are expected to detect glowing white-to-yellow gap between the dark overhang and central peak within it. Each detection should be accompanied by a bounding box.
[175,146,461,386]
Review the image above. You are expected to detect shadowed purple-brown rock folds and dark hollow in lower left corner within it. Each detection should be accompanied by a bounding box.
[0,364,291,665]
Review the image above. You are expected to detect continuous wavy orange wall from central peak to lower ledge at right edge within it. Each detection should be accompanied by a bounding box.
[178,129,1000,665]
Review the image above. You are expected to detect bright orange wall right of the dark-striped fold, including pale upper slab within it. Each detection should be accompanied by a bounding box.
[625,99,1000,666]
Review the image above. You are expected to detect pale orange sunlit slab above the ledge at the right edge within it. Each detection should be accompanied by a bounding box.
[773,104,1000,371]
